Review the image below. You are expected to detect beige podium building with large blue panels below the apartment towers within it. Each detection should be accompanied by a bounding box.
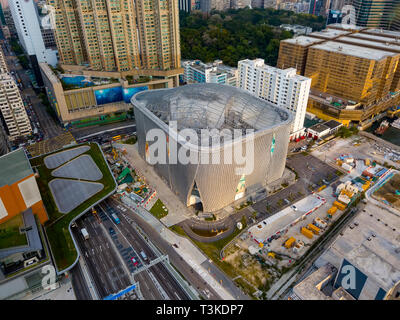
[40,63,175,126]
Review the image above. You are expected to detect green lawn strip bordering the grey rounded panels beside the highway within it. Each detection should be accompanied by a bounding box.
[31,143,116,271]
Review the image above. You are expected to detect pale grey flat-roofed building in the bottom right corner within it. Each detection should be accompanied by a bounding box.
[316,203,400,300]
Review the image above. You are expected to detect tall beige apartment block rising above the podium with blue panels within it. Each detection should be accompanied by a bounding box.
[48,0,180,72]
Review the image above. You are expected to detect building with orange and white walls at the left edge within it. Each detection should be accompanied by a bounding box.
[0,149,51,299]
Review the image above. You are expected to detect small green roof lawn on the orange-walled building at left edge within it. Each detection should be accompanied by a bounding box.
[0,214,28,249]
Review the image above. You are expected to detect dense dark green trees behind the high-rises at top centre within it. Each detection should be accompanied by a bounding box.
[180,8,325,66]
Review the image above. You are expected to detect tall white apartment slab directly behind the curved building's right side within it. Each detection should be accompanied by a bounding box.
[238,59,311,139]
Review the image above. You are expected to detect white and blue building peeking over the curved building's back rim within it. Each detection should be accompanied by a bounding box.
[182,60,238,87]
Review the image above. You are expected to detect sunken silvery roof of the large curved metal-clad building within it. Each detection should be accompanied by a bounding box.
[133,84,291,133]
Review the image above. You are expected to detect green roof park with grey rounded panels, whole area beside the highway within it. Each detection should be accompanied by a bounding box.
[30,143,116,272]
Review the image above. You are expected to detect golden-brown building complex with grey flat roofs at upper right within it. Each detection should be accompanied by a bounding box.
[278,24,400,128]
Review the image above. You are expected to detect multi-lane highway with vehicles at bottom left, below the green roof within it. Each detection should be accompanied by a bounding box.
[73,202,190,300]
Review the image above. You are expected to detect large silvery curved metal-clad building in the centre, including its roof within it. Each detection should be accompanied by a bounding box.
[131,83,293,212]
